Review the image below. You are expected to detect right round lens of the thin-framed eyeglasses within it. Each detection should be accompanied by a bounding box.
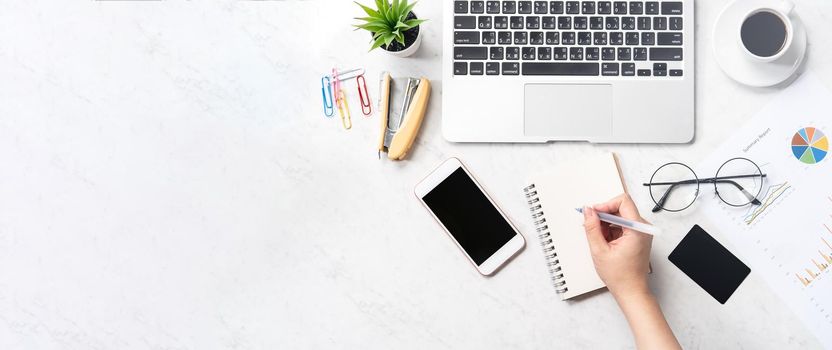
[714,158,763,207]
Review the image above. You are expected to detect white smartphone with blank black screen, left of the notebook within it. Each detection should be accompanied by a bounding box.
[414,158,526,276]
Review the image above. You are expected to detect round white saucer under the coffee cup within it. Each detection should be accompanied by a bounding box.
[713,0,806,87]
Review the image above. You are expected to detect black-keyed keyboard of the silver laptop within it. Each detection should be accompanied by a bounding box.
[453,0,689,77]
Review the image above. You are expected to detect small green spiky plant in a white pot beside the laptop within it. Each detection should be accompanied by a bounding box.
[355,0,425,57]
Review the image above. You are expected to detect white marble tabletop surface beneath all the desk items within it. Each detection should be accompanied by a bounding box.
[0,0,832,349]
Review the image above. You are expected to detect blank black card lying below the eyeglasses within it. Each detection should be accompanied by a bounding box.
[667,225,751,304]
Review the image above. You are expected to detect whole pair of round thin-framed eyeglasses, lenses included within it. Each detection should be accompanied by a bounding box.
[644,157,766,213]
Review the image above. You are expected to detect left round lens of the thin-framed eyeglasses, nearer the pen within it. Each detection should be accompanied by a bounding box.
[650,163,699,211]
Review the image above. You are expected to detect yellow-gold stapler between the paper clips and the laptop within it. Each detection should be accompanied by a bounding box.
[378,72,430,160]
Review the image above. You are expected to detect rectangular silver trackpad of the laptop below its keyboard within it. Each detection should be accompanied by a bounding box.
[524,84,612,141]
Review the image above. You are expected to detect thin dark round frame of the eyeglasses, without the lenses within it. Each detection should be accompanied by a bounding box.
[643,157,766,213]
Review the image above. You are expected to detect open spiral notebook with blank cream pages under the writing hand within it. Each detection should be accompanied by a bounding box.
[523,153,624,300]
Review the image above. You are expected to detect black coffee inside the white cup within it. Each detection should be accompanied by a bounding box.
[740,10,787,57]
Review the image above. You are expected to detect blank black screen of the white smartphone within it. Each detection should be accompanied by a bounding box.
[422,167,517,265]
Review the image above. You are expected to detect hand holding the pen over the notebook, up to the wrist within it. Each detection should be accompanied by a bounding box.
[584,194,653,298]
